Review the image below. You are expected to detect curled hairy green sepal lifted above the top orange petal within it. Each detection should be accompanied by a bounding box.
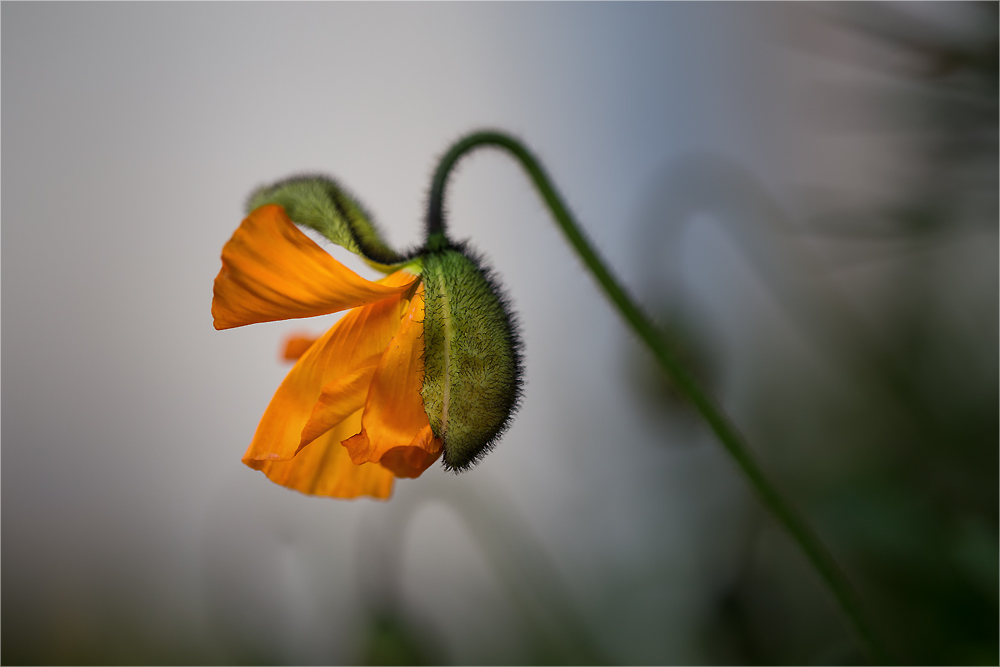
[247,176,406,270]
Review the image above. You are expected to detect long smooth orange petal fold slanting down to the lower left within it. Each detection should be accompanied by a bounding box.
[243,271,412,467]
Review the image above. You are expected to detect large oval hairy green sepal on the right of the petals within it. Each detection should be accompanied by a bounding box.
[421,247,521,470]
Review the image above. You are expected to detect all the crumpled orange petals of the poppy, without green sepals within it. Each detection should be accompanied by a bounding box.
[212,204,442,498]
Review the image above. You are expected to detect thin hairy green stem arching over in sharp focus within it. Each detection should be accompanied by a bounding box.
[427,132,889,664]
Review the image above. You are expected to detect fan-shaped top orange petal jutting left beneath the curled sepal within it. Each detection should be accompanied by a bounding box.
[212,204,415,329]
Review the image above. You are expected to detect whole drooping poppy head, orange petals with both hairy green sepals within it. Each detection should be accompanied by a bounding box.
[212,177,521,498]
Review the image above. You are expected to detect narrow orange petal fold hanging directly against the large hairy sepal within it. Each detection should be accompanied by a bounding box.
[344,286,441,476]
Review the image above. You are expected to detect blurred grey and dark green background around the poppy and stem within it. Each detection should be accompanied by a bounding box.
[0,3,1000,664]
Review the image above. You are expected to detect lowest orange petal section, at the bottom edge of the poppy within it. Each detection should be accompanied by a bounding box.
[247,410,394,499]
